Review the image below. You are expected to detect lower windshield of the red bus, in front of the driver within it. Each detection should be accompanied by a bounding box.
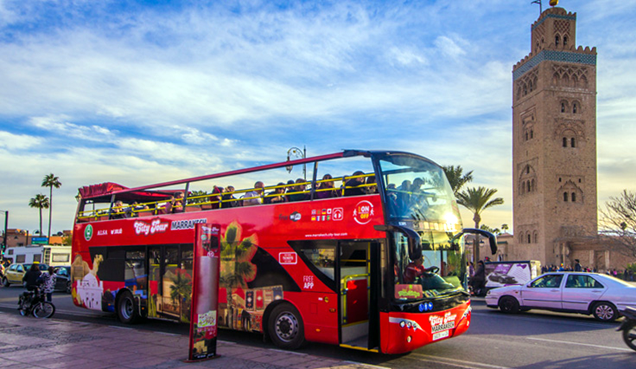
[394,231,467,300]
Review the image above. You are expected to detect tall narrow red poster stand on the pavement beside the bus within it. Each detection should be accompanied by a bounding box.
[188,223,220,361]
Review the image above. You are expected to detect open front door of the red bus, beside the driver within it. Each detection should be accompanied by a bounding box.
[337,241,381,351]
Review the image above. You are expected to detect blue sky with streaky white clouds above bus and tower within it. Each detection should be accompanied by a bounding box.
[0,0,636,232]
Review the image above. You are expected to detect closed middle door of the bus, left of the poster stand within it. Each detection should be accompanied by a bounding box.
[148,245,192,322]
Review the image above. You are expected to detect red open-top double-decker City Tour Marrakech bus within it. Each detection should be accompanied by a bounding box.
[72,150,496,354]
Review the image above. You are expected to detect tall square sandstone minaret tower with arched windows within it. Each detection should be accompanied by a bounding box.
[512,2,598,265]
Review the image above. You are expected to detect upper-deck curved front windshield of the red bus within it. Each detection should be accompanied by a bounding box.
[379,155,461,227]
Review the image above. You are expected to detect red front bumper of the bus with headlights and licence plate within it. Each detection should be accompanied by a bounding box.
[380,302,470,354]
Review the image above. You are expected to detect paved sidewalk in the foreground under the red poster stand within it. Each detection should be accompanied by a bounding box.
[0,312,388,369]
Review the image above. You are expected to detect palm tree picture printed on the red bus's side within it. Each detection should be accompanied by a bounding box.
[219,221,258,328]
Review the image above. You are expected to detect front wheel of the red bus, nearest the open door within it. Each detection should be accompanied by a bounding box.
[268,303,305,350]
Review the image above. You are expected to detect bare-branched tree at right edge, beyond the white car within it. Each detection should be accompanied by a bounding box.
[599,190,636,257]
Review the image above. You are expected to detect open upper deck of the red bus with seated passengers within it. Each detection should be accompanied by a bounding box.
[77,150,422,222]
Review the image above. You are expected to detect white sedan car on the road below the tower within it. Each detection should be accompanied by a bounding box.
[486,272,636,321]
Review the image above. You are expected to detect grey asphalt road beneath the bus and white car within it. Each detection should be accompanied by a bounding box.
[0,287,636,369]
